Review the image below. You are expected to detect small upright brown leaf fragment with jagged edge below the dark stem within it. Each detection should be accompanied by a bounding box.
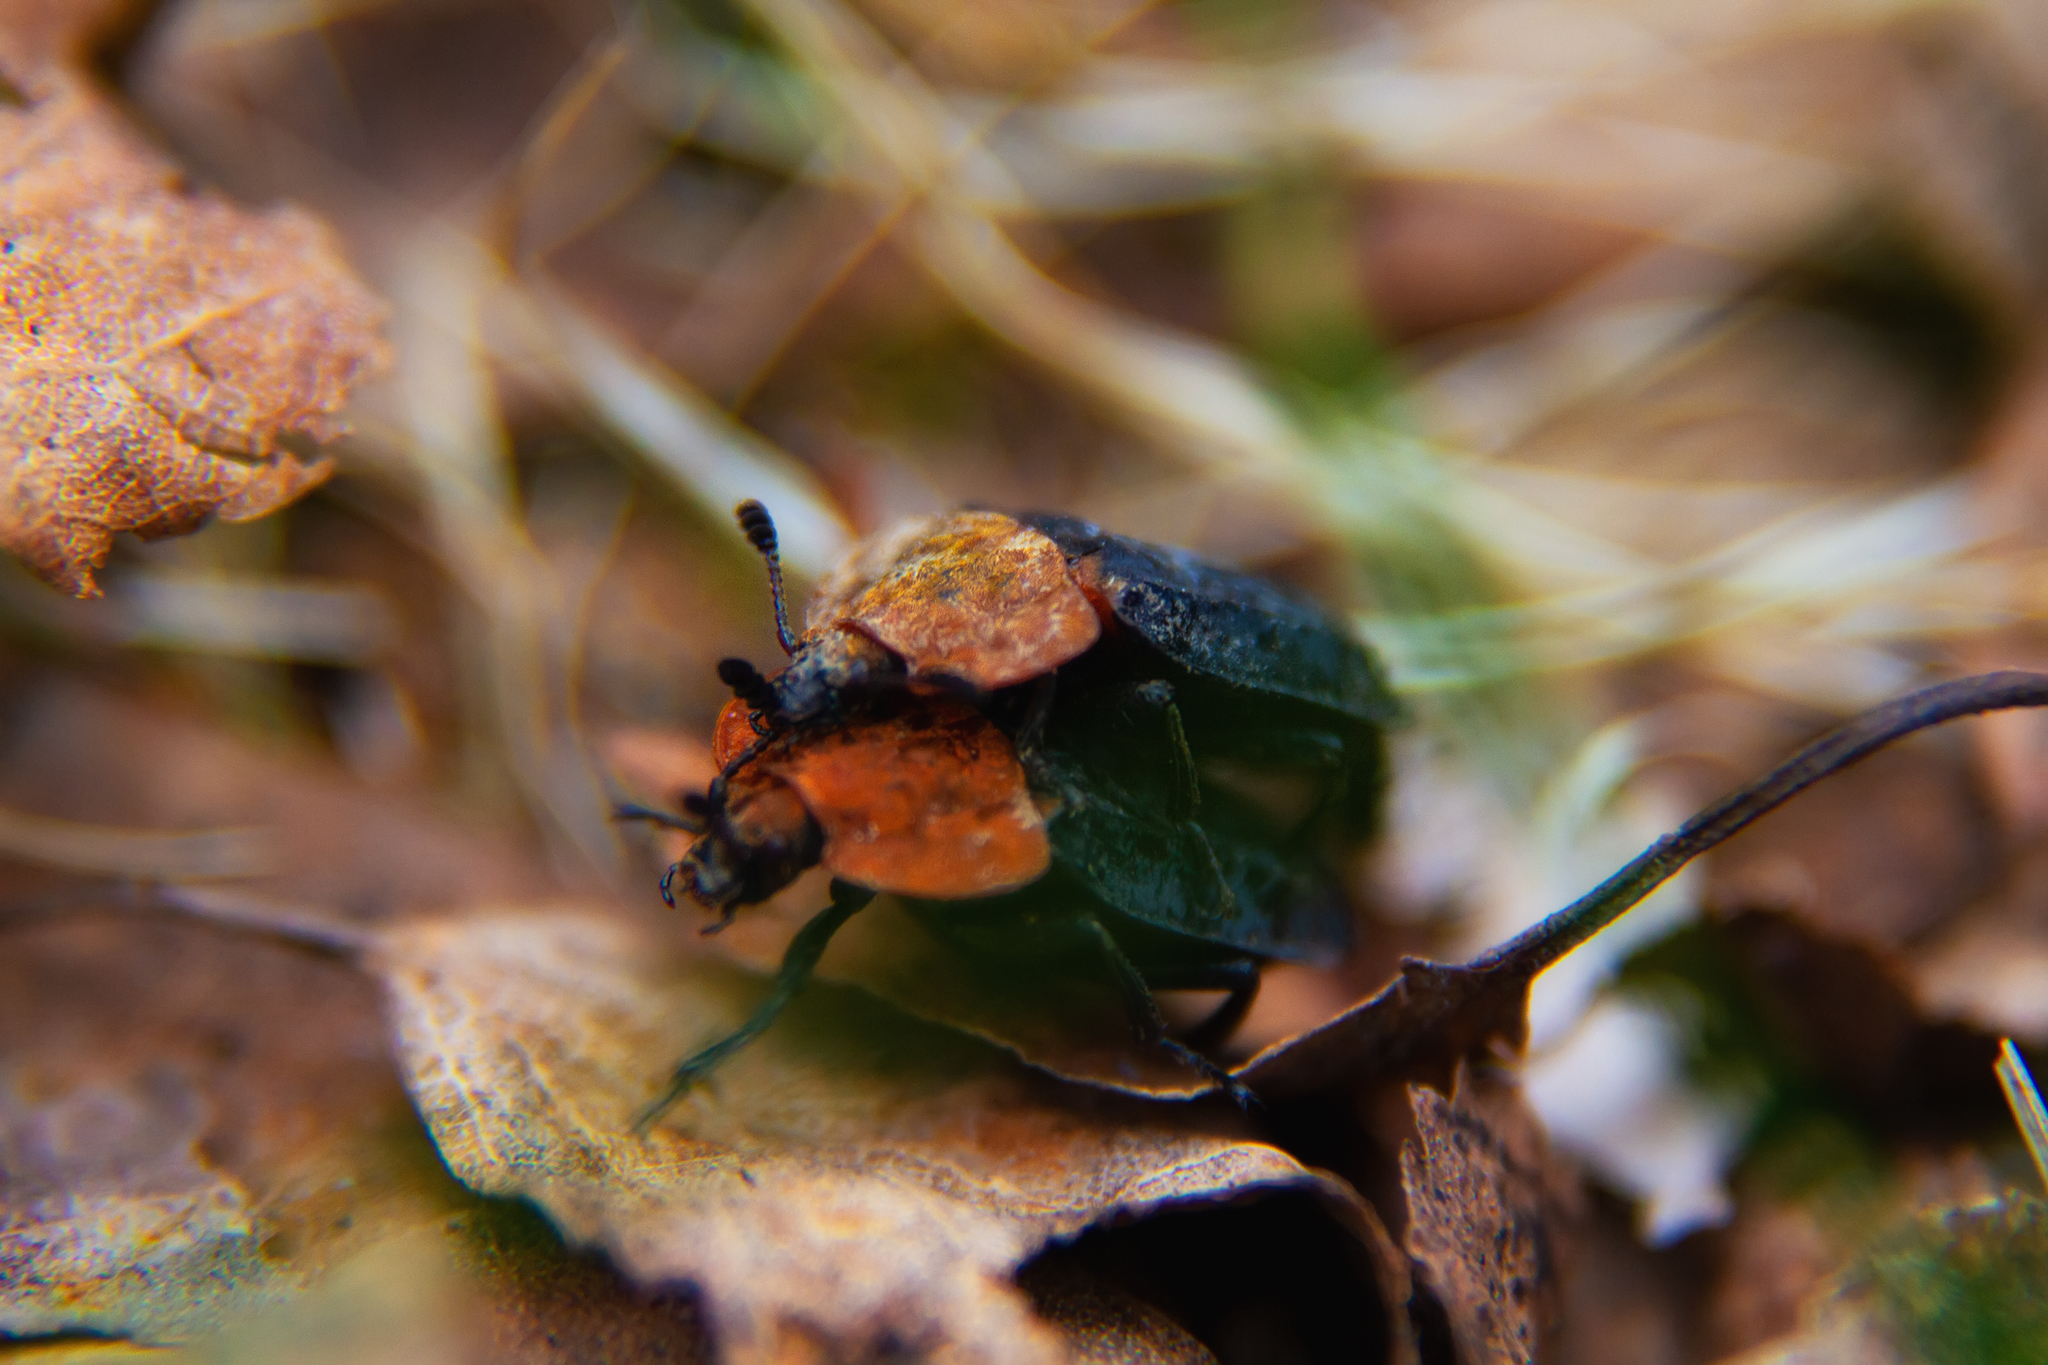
[1401,1070,1575,1365]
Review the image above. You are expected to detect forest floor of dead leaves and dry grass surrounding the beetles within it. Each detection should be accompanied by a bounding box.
[19,0,2048,1365]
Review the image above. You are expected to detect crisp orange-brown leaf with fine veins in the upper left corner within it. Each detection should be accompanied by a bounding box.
[0,4,387,596]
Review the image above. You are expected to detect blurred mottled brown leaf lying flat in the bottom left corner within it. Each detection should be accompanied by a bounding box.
[0,896,450,1340]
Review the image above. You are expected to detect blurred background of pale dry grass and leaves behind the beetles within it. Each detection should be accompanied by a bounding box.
[12,0,2048,1359]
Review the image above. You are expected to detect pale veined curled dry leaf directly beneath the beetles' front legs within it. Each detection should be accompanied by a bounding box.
[373,915,1370,1363]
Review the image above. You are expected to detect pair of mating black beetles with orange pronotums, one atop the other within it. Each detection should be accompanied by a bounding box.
[618,501,1399,1124]
